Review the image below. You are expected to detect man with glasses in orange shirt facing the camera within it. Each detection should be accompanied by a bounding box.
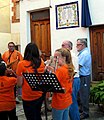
[2,42,23,72]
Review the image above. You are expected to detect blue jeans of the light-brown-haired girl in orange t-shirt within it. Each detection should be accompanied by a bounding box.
[52,106,70,120]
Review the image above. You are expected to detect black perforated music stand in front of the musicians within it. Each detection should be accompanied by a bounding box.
[23,73,65,120]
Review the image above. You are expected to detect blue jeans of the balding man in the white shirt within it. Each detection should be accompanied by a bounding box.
[69,77,80,120]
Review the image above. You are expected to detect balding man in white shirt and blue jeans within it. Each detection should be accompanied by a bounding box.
[62,40,80,120]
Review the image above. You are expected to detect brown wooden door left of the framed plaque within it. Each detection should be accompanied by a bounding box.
[31,10,51,60]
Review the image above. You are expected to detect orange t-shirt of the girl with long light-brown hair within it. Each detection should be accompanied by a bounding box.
[51,65,72,110]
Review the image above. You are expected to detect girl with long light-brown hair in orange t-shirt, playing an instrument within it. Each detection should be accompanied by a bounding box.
[47,48,74,120]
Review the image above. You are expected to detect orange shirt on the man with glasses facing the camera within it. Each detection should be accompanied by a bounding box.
[2,50,23,72]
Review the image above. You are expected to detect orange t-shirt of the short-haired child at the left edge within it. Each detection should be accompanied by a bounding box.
[0,76,17,111]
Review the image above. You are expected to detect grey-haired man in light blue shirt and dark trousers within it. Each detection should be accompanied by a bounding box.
[76,38,91,119]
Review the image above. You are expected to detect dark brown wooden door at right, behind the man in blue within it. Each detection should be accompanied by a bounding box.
[90,25,104,81]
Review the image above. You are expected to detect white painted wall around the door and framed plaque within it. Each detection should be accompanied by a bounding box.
[20,0,104,54]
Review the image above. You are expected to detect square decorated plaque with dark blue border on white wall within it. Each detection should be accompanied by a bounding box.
[55,1,79,29]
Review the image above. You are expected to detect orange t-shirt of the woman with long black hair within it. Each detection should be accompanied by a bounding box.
[16,60,45,101]
